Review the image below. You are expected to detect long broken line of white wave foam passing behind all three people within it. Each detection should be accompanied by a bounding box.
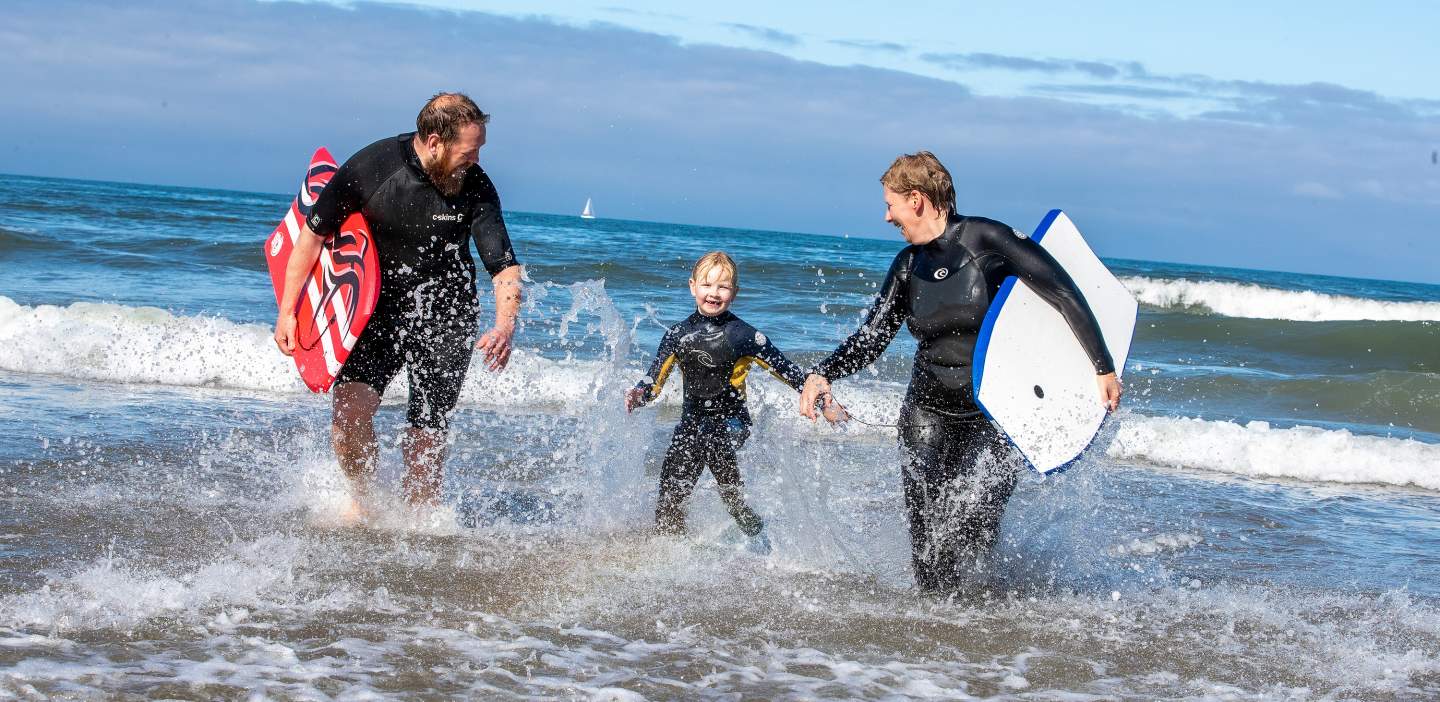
[0,293,1440,491]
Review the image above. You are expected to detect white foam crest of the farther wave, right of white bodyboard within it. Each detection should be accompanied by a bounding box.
[1120,276,1440,322]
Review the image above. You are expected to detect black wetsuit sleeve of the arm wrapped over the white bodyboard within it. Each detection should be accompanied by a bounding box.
[985,224,1115,375]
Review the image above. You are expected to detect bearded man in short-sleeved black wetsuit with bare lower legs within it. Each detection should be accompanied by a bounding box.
[275,94,521,503]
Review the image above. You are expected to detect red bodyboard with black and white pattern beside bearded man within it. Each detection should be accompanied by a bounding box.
[265,147,380,393]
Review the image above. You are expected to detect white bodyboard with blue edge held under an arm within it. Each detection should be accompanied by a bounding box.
[973,210,1139,473]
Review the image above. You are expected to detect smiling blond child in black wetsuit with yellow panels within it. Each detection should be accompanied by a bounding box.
[625,252,840,552]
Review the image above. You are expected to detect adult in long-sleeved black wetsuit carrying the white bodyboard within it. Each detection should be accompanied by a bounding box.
[801,151,1120,591]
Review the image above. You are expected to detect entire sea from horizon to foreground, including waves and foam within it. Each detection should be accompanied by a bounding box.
[0,176,1440,701]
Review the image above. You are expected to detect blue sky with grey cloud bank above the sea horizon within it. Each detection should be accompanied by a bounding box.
[8,0,1440,282]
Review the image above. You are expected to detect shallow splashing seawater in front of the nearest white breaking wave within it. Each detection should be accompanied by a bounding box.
[0,375,1440,699]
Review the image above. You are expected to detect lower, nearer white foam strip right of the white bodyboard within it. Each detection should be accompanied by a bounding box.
[1109,414,1440,491]
